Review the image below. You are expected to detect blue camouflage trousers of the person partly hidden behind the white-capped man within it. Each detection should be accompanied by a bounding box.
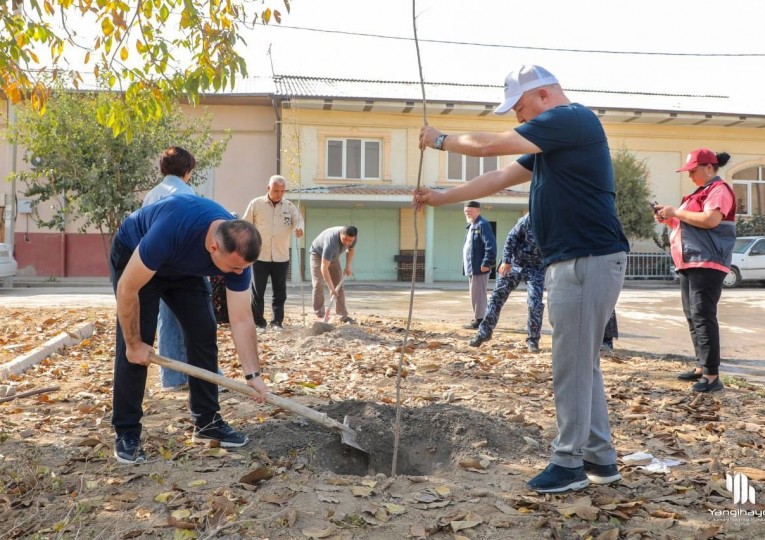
[478,267,545,345]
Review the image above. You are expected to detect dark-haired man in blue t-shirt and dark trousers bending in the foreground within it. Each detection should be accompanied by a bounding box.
[109,195,268,463]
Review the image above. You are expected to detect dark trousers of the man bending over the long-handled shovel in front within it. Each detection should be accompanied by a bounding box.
[109,240,220,436]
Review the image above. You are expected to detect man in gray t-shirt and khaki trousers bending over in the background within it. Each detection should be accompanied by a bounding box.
[310,225,359,323]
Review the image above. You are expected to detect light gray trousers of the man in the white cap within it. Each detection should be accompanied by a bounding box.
[546,252,627,467]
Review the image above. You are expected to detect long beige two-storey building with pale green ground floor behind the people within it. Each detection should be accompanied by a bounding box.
[0,76,765,281]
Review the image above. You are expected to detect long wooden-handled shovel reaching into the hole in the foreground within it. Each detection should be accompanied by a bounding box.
[149,353,367,454]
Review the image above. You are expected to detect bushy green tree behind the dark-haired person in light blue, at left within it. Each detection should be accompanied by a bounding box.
[9,81,231,244]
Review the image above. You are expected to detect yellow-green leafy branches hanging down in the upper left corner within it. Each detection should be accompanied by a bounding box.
[0,0,290,136]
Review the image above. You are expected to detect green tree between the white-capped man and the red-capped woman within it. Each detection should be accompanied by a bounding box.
[612,148,656,239]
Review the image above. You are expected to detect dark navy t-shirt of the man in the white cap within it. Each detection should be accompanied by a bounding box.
[515,103,629,265]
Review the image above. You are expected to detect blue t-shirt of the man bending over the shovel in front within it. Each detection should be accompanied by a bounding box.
[117,195,252,291]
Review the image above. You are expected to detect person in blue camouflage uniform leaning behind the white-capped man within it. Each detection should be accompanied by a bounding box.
[470,214,545,352]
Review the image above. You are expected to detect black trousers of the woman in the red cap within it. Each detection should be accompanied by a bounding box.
[678,268,726,375]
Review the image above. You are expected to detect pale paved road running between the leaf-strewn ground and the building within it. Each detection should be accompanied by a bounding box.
[0,282,765,383]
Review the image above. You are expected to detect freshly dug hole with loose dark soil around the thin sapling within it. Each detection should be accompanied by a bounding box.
[251,401,528,476]
